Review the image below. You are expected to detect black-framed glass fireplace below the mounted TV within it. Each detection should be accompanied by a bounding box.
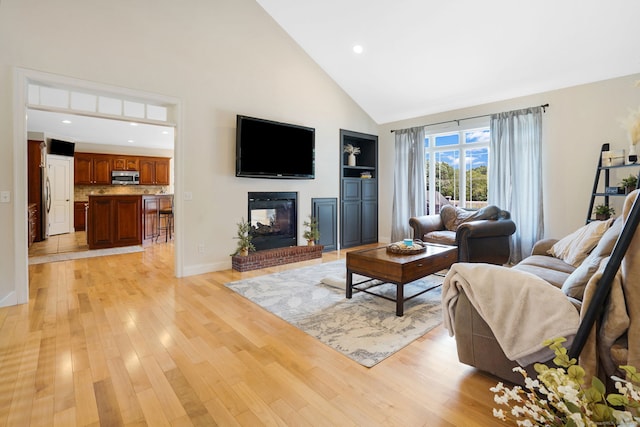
[248,192,298,251]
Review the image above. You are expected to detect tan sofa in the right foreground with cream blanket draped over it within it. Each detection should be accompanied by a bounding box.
[443,190,640,390]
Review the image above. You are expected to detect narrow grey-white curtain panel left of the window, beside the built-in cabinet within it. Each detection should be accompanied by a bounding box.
[391,127,426,242]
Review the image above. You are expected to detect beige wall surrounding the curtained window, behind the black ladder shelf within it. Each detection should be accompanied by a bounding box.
[378,74,640,241]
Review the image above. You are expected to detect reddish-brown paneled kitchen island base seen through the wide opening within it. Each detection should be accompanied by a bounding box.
[86,195,142,249]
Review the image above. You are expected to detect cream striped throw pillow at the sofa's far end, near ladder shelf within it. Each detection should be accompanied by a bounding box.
[547,219,613,267]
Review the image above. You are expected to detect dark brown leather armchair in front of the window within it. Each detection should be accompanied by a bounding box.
[409,205,516,265]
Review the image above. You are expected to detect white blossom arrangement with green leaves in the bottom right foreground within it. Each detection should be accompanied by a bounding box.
[490,338,640,427]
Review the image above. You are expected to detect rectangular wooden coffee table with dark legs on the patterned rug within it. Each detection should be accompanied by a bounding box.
[346,243,458,316]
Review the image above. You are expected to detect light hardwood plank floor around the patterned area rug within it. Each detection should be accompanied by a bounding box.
[0,243,510,426]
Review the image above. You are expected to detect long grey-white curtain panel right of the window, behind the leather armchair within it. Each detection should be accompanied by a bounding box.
[488,107,544,263]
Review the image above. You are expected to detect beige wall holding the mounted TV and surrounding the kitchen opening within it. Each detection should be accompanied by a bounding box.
[0,0,377,305]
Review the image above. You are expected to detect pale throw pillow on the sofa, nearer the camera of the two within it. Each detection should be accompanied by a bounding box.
[562,217,622,301]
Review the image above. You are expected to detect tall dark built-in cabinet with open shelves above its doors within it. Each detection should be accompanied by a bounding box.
[340,129,378,248]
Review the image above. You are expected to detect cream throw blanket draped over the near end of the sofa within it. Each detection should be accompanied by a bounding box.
[442,263,580,366]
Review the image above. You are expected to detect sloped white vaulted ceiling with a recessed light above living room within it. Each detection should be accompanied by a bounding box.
[257,0,640,124]
